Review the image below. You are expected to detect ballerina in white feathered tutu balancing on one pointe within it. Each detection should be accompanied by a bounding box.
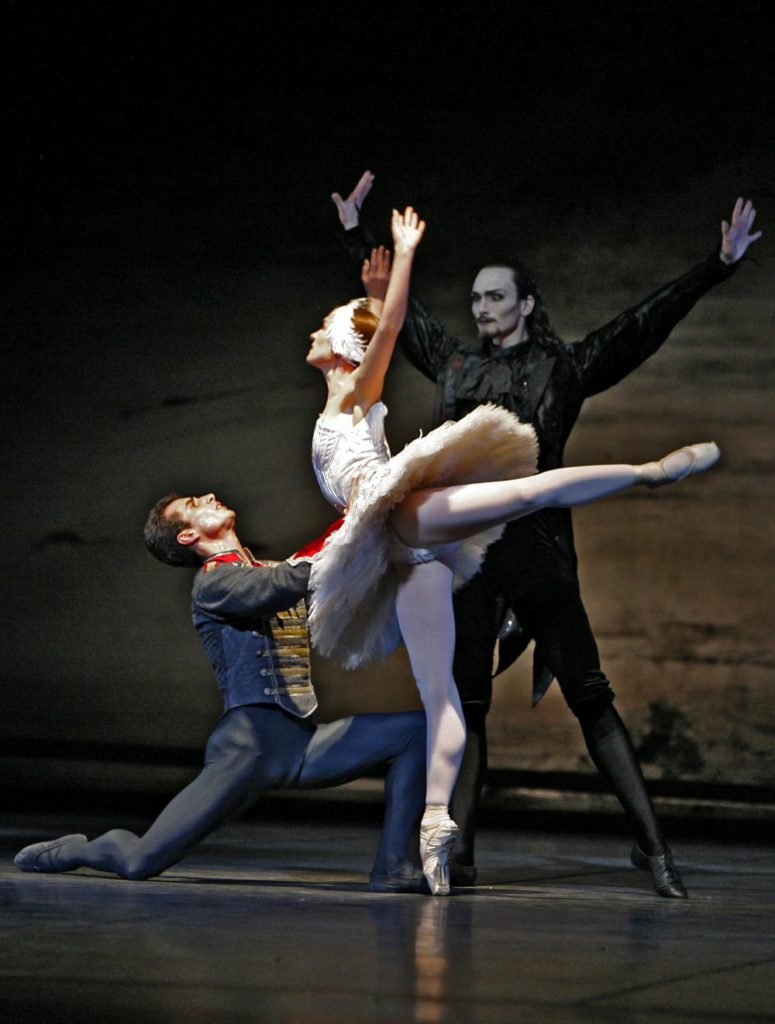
[306,207,719,896]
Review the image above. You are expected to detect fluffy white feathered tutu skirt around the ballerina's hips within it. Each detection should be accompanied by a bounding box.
[309,404,539,669]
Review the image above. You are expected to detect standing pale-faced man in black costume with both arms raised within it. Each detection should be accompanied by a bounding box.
[332,171,761,898]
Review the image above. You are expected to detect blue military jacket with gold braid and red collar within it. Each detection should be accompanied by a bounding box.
[191,551,317,718]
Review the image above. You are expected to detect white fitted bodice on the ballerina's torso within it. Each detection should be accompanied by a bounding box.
[312,401,390,512]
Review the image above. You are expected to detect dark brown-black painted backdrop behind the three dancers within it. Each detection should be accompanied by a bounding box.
[0,2,775,788]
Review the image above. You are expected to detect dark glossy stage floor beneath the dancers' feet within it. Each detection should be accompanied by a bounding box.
[0,815,775,1024]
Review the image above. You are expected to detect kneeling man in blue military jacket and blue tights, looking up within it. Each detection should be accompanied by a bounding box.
[14,494,425,892]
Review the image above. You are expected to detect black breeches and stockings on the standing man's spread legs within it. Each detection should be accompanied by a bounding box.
[454,513,664,851]
